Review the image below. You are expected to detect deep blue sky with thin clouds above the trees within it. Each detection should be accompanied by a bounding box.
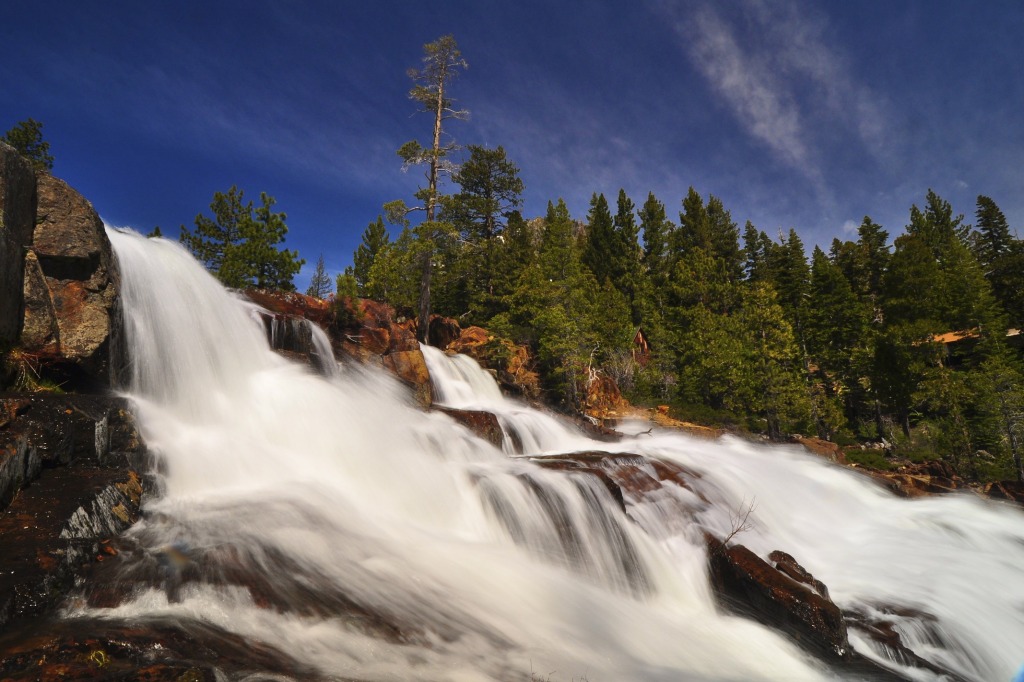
[0,0,1024,289]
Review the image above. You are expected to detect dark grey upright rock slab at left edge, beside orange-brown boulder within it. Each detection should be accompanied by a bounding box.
[0,142,36,348]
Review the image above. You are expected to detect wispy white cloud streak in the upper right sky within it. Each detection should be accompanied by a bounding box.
[660,0,885,194]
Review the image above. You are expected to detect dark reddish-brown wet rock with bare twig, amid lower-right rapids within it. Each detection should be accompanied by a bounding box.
[706,535,851,659]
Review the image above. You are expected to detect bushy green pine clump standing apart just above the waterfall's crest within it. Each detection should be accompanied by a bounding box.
[180,185,305,291]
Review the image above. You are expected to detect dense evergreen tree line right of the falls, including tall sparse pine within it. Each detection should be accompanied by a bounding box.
[348,36,1024,479]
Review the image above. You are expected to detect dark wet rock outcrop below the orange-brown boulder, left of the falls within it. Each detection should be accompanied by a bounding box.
[0,394,146,632]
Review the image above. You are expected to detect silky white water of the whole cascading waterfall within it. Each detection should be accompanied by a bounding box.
[90,232,1024,682]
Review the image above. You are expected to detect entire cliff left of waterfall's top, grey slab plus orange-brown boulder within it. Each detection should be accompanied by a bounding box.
[0,143,121,391]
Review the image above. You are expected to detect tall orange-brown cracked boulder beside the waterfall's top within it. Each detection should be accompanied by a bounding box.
[20,173,121,388]
